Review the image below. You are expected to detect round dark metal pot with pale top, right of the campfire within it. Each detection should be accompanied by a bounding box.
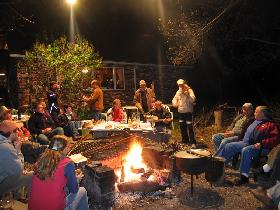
[174,151,210,175]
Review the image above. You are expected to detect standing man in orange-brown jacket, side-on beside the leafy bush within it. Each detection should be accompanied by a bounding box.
[83,80,104,120]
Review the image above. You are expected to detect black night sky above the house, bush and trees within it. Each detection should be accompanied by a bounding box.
[0,0,280,103]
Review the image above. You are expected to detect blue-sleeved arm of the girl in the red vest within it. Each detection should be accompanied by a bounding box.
[64,162,79,193]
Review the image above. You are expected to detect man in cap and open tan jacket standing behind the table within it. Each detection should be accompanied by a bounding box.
[133,80,155,117]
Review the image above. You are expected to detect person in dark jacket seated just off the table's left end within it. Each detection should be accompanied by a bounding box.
[58,105,81,137]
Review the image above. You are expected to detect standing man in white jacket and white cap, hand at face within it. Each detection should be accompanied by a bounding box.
[172,79,196,147]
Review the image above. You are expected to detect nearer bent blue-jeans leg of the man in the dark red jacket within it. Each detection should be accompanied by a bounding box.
[240,145,269,174]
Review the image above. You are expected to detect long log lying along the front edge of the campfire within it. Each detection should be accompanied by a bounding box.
[117,181,167,193]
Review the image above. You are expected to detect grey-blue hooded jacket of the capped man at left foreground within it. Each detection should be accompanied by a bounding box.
[0,134,24,184]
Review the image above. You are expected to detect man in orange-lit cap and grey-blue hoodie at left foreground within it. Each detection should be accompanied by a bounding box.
[0,120,32,196]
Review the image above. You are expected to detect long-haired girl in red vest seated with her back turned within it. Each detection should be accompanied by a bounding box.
[28,135,89,210]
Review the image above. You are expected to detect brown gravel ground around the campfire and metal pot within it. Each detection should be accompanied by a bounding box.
[25,124,274,210]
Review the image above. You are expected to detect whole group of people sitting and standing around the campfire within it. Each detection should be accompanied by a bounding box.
[0,80,280,210]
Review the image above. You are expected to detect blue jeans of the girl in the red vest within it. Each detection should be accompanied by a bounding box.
[65,187,89,210]
